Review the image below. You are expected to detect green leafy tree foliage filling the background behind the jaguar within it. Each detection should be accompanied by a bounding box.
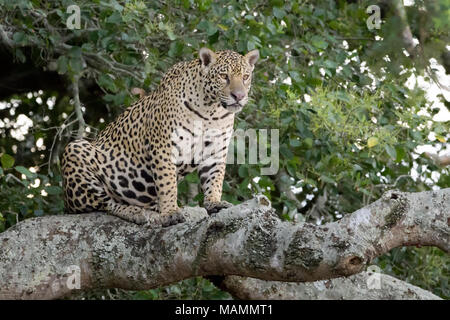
[0,0,450,298]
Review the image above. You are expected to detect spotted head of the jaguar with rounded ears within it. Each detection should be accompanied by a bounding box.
[199,48,259,112]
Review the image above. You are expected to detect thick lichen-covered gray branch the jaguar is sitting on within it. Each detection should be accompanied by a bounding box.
[0,188,450,299]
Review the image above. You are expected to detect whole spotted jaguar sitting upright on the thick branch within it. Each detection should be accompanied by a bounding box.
[62,48,259,226]
